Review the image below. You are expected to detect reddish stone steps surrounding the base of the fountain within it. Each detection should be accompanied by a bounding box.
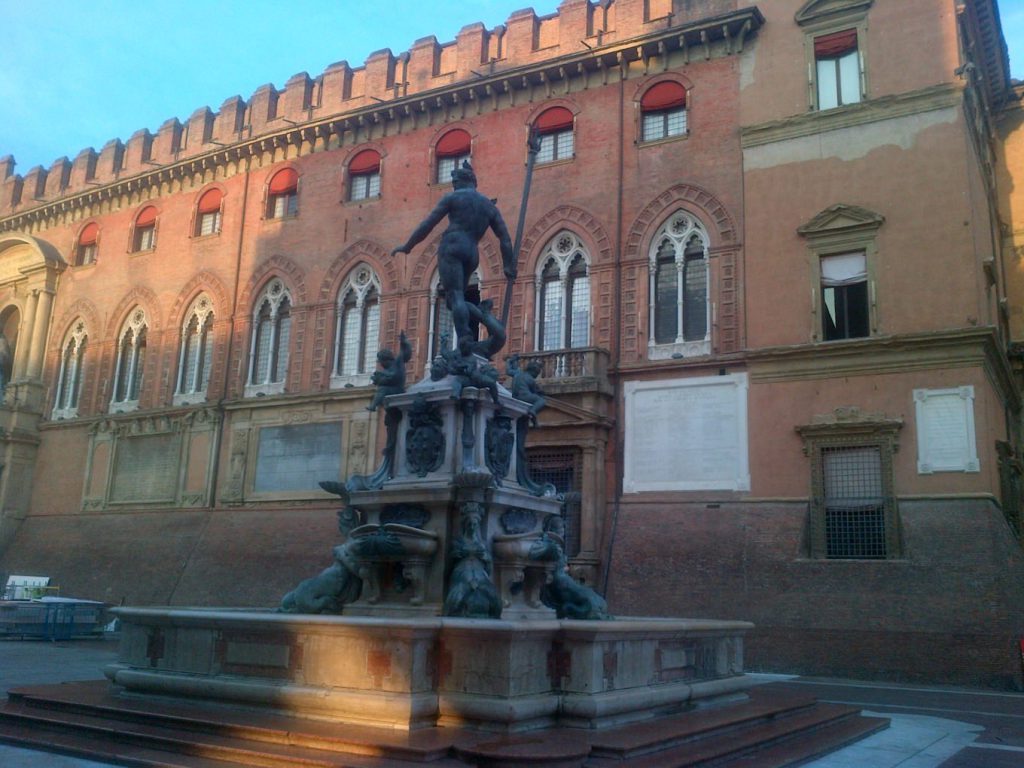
[0,681,888,768]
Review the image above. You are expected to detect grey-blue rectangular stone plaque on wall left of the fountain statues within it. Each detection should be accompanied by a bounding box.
[253,422,341,494]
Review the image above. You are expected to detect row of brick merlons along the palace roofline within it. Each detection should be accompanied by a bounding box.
[0,0,738,216]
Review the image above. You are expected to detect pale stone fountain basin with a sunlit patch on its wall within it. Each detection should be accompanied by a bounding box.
[105,608,752,732]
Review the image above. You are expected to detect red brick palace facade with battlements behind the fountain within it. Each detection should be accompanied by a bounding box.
[0,0,1024,687]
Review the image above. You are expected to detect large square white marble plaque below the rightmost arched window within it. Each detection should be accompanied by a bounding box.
[624,374,751,494]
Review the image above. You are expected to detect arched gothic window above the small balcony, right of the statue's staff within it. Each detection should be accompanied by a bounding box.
[535,229,590,350]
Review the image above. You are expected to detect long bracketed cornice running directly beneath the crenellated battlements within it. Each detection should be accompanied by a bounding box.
[0,7,764,232]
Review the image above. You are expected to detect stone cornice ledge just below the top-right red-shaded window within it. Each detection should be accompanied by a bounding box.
[740,83,963,150]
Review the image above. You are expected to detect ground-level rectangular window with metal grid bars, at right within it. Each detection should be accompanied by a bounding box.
[821,445,886,560]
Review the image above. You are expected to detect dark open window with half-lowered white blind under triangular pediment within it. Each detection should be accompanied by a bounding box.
[821,251,870,341]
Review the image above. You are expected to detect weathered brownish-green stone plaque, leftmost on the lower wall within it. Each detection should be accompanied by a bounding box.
[111,433,181,503]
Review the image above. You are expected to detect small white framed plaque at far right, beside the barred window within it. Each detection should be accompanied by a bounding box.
[913,386,980,474]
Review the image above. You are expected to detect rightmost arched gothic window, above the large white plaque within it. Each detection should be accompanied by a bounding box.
[647,211,711,359]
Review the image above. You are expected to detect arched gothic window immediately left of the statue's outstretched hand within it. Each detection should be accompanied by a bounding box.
[331,264,381,386]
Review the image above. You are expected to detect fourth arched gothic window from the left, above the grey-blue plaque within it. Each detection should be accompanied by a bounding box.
[246,279,292,395]
